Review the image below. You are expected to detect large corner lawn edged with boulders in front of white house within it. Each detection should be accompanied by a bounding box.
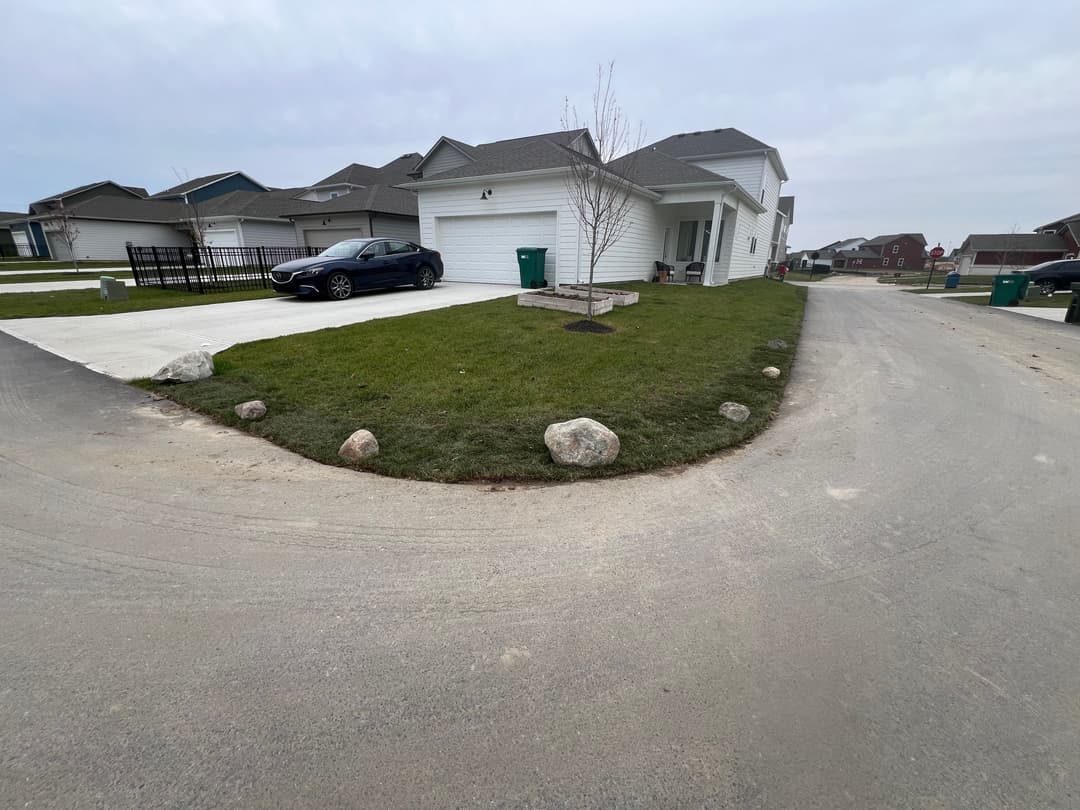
[139,280,806,482]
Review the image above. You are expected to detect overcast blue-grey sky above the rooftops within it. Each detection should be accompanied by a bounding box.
[0,0,1080,248]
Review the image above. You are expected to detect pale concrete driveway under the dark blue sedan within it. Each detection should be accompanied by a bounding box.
[0,282,521,379]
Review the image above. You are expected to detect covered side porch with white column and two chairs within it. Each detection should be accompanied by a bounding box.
[657,191,738,286]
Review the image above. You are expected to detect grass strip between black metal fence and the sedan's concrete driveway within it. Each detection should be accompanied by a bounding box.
[0,285,274,319]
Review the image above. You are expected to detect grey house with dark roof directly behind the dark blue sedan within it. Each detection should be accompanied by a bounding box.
[282,152,421,247]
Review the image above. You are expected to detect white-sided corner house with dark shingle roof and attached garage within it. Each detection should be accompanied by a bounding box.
[402,129,787,284]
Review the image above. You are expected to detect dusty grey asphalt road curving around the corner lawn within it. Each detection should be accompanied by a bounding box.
[0,285,1080,809]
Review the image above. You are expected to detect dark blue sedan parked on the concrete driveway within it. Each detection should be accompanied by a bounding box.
[270,239,443,301]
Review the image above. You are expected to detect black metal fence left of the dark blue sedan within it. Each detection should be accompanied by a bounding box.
[127,245,324,293]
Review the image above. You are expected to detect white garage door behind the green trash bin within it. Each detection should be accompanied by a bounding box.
[435,212,555,284]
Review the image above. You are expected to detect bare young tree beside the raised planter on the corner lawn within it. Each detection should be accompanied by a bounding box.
[563,62,645,321]
